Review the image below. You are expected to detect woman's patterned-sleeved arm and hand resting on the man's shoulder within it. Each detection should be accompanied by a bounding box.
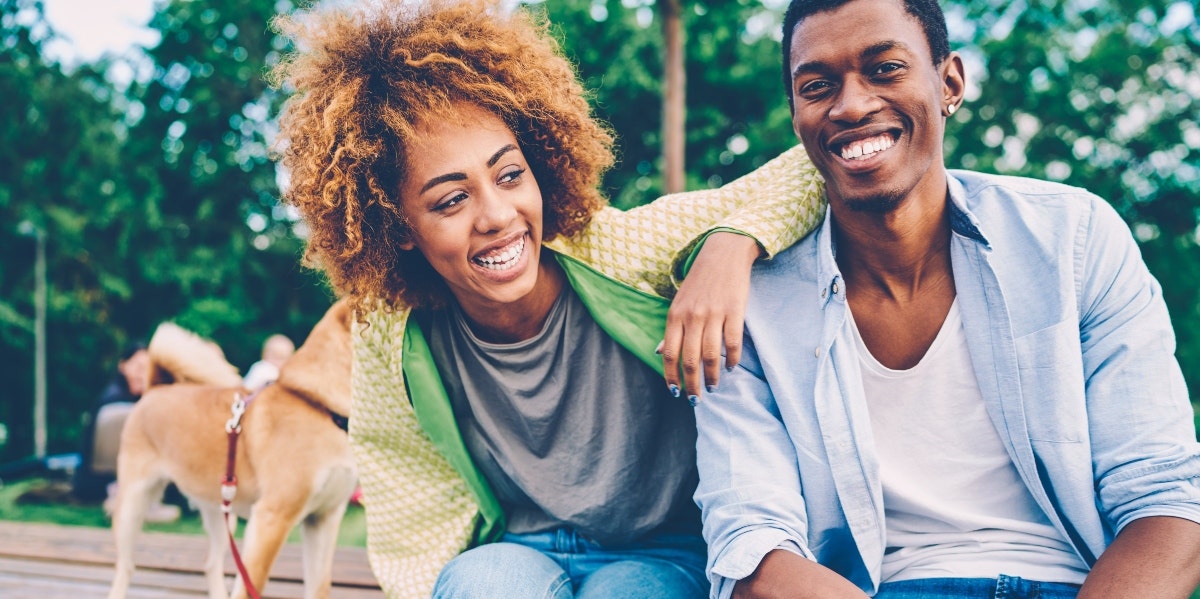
[547,145,826,397]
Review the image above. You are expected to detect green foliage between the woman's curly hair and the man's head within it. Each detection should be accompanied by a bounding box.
[539,0,796,208]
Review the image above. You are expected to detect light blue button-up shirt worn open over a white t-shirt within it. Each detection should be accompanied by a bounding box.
[696,170,1200,598]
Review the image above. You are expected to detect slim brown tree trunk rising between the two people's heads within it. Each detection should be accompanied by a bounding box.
[658,0,688,193]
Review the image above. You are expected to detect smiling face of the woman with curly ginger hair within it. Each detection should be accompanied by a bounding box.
[401,104,542,313]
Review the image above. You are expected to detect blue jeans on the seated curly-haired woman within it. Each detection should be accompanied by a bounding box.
[433,528,708,599]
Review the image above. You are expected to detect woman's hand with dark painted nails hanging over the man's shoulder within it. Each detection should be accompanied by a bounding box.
[660,230,761,403]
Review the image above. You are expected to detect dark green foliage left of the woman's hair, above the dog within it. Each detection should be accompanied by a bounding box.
[0,0,331,461]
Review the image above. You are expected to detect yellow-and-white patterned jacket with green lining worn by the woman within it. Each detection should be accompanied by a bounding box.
[350,146,824,598]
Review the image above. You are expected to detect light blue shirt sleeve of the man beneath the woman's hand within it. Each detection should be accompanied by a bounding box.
[696,336,812,598]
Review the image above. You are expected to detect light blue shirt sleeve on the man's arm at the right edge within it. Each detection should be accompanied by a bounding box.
[1080,199,1200,531]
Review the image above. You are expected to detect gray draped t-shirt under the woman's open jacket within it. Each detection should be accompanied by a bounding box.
[413,286,700,545]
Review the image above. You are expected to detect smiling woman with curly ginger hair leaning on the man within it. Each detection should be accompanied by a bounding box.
[267,0,822,599]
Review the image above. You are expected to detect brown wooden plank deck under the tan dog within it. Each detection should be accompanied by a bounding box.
[0,521,384,599]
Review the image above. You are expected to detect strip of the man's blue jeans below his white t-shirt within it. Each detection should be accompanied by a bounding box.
[875,574,1079,599]
